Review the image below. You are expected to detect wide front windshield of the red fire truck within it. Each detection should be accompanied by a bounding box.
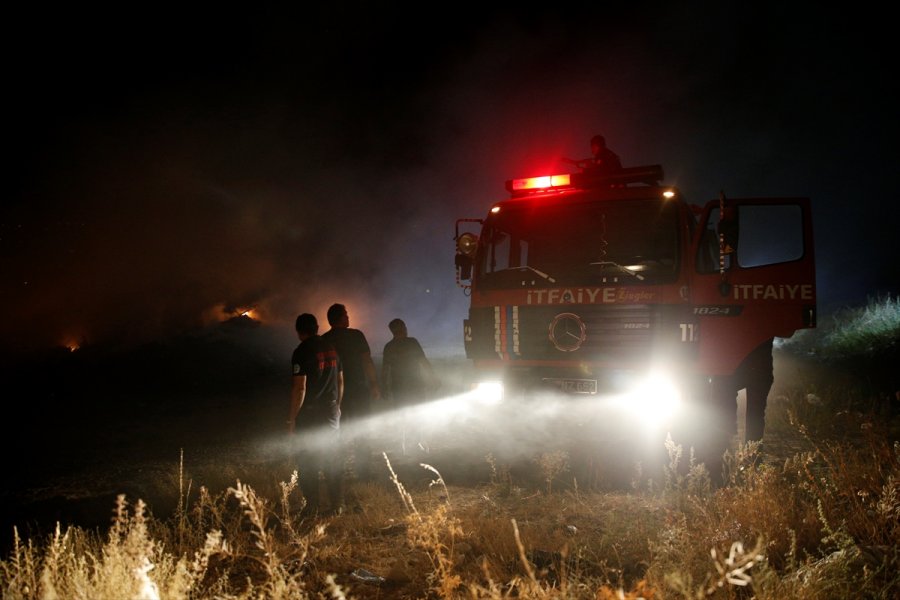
[477,198,678,288]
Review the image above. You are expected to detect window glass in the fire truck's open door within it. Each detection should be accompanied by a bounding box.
[737,204,803,268]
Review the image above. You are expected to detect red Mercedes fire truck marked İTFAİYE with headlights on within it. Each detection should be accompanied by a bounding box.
[454,165,816,472]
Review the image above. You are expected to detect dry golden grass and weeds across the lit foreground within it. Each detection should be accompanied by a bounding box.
[0,380,900,600]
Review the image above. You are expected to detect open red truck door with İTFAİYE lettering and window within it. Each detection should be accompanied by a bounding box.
[691,198,816,375]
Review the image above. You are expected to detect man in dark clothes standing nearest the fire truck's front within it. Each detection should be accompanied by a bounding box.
[381,319,437,454]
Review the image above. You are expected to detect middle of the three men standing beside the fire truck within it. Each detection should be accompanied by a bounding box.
[322,303,381,480]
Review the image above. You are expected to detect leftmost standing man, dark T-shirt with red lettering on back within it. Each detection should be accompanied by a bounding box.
[287,313,344,515]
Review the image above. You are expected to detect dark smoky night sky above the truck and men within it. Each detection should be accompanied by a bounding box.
[0,2,900,355]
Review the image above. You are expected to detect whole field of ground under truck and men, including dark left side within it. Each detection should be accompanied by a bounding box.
[0,299,900,599]
